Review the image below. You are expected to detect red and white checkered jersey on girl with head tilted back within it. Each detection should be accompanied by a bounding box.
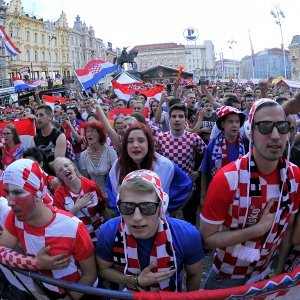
[54,177,103,241]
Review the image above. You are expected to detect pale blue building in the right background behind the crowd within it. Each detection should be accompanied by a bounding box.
[241,48,291,79]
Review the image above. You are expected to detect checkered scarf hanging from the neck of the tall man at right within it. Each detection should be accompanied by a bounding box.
[232,151,294,262]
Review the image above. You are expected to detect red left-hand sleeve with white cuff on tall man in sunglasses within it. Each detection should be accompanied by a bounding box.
[200,164,236,224]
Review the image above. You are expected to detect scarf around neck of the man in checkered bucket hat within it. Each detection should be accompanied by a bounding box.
[211,132,245,177]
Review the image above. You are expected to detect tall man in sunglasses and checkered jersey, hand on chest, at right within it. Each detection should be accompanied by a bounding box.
[200,99,300,289]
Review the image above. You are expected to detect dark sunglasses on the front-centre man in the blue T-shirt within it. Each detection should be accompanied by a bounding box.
[117,201,161,216]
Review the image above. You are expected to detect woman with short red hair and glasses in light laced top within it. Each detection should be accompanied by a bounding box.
[80,121,118,198]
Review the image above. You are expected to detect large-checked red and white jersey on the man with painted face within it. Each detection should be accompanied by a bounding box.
[5,206,94,292]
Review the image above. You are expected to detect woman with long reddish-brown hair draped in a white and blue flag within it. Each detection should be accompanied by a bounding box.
[106,123,192,212]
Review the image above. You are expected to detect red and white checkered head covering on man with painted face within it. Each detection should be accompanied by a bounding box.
[3,159,47,198]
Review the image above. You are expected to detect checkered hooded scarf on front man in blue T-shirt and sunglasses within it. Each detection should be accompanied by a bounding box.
[113,170,177,291]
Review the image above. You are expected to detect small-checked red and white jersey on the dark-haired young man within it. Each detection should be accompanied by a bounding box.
[154,131,206,174]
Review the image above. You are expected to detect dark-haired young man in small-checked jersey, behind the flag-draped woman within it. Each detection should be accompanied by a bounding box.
[154,104,206,224]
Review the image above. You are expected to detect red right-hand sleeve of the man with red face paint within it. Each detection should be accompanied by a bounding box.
[73,222,95,261]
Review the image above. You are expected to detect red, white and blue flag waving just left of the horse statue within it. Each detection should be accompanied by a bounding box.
[74,60,118,89]
